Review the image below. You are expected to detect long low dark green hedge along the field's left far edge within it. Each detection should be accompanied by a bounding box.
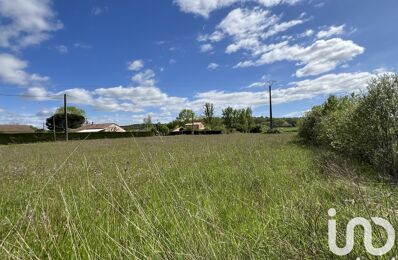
[0,132,154,144]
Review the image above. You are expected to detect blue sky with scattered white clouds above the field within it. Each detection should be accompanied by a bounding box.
[0,0,398,126]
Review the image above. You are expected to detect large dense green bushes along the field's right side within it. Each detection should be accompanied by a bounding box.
[299,74,398,177]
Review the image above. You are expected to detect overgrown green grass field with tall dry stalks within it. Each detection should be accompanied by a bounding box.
[0,133,398,259]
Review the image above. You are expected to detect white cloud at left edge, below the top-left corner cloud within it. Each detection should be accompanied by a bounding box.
[0,54,49,87]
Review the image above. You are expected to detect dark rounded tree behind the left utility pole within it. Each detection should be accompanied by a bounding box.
[46,107,86,131]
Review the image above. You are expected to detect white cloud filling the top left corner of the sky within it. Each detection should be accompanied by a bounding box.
[0,0,63,49]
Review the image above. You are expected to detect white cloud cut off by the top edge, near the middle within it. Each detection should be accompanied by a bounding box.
[174,0,300,18]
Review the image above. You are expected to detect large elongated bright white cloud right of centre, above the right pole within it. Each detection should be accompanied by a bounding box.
[236,38,365,77]
